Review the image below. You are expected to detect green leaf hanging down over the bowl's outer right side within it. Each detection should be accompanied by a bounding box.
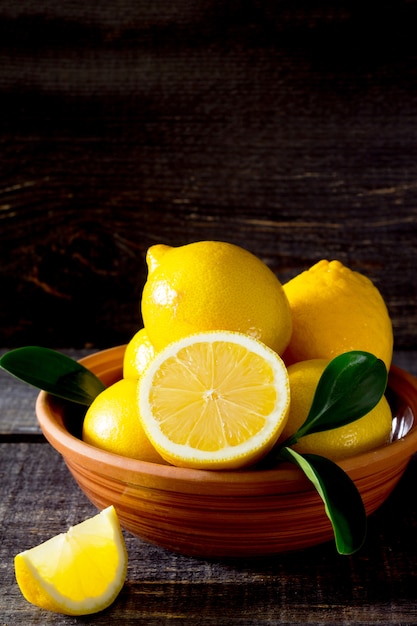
[280,448,367,555]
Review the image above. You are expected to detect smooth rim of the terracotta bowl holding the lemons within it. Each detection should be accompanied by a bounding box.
[36,346,417,489]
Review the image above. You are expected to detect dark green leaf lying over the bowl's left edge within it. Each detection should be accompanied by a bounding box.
[0,346,105,406]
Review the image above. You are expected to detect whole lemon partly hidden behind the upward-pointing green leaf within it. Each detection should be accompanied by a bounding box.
[280,359,392,461]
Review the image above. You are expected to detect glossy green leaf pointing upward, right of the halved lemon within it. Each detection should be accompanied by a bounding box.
[283,350,388,446]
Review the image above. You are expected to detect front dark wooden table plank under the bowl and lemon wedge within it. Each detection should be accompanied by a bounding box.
[0,443,417,625]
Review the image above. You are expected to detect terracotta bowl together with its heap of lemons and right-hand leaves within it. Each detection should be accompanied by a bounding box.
[36,242,417,558]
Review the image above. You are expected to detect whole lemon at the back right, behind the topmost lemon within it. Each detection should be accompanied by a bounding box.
[284,260,393,369]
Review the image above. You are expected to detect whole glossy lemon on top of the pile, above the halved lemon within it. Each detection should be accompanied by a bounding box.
[141,241,291,354]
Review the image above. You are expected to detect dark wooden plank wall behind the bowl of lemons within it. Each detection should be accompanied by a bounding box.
[0,0,417,349]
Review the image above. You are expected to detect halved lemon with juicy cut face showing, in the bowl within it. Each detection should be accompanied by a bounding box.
[139,331,290,469]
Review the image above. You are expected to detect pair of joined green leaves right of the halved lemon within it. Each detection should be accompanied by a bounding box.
[267,350,388,555]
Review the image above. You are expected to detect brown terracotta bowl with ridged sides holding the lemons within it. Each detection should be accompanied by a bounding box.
[36,346,417,557]
